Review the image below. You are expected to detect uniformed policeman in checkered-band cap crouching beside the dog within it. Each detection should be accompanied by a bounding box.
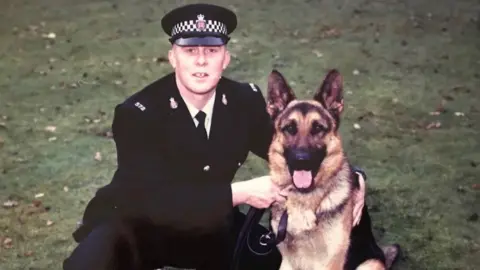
[64,4,363,270]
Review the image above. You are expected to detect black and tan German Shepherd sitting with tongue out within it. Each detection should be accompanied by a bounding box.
[267,70,400,270]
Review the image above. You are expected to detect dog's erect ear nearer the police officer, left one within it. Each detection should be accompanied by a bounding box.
[267,69,295,119]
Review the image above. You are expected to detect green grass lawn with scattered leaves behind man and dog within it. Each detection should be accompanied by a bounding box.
[0,0,480,270]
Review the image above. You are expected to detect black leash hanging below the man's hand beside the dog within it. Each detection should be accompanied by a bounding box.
[231,207,288,270]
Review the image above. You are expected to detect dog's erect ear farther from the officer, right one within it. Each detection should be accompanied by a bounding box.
[313,69,343,117]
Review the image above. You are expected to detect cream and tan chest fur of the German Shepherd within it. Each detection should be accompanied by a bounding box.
[271,170,353,270]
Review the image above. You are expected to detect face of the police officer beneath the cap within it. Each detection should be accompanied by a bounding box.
[168,45,230,94]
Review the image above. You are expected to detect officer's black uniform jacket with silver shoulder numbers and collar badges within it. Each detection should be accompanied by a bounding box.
[74,73,273,242]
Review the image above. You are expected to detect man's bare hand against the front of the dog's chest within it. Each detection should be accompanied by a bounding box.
[232,176,285,209]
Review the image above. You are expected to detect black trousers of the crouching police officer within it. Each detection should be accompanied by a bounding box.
[63,211,281,270]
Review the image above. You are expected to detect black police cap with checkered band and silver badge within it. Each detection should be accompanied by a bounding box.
[162,4,237,46]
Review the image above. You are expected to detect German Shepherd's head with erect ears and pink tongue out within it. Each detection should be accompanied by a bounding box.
[267,70,344,192]
